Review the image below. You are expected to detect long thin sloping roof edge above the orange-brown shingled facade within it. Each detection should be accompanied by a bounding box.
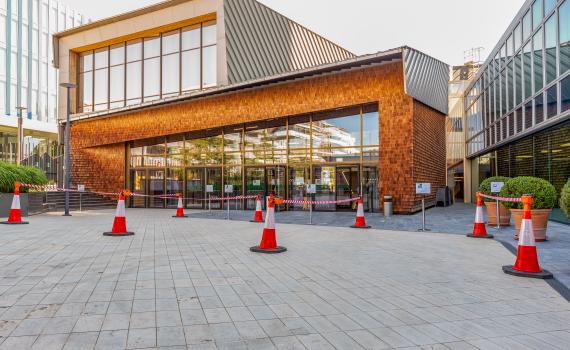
[66,47,403,124]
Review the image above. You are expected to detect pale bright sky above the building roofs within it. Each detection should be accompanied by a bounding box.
[70,0,524,65]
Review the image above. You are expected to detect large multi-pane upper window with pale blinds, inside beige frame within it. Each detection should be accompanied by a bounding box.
[79,22,217,112]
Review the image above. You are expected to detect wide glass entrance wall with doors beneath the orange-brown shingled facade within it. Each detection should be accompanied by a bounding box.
[128,104,379,210]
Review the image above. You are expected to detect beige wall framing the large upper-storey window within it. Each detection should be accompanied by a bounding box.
[57,0,223,120]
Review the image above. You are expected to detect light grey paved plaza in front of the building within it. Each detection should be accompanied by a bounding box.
[0,209,570,350]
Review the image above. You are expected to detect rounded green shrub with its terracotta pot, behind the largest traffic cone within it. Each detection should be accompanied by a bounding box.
[500,176,557,242]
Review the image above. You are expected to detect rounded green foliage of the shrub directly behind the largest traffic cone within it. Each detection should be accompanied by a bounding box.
[500,176,558,209]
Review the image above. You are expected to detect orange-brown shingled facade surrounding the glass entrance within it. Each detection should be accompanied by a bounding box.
[71,62,445,213]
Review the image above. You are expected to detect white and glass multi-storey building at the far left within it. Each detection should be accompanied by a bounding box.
[0,0,84,180]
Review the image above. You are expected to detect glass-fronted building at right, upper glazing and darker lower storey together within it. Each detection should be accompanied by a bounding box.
[465,0,570,197]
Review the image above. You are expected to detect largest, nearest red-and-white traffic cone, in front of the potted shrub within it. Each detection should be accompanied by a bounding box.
[503,195,552,279]
